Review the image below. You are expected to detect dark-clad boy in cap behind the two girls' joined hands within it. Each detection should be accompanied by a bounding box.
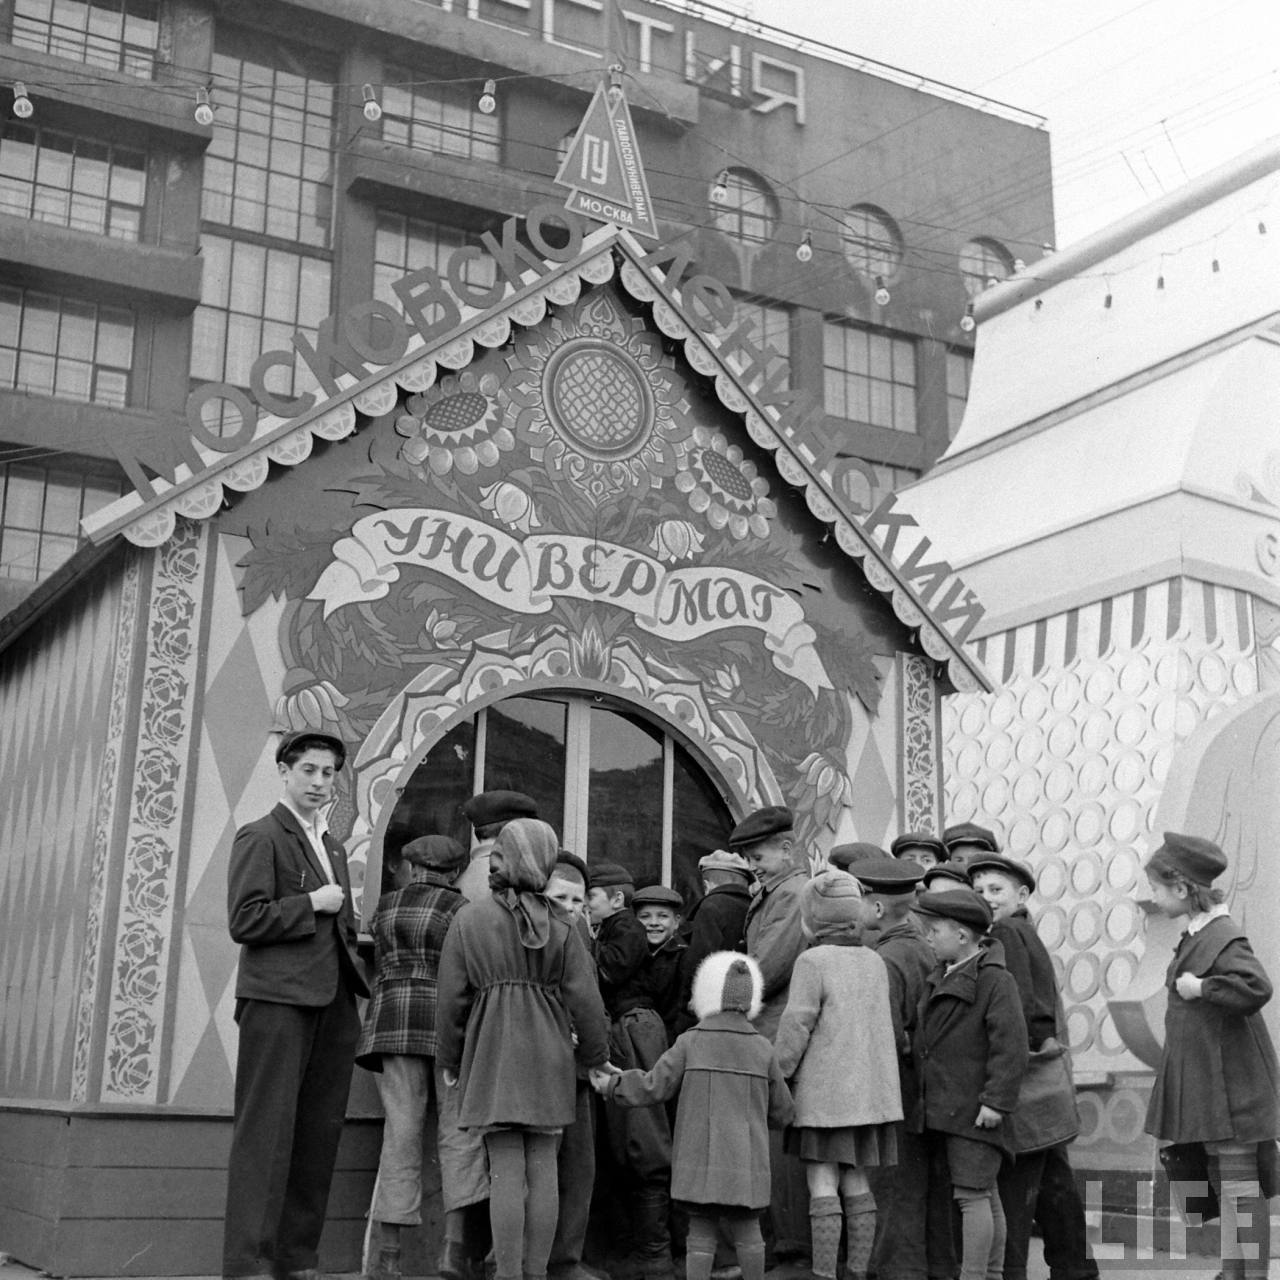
[586,863,673,1280]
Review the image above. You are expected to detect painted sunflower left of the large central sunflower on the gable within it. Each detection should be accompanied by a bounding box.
[396,369,516,476]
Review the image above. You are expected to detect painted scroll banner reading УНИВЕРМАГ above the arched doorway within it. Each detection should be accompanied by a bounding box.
[310,508,832,694]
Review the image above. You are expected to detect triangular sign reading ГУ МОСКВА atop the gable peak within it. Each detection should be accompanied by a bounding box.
[556,84,658,239]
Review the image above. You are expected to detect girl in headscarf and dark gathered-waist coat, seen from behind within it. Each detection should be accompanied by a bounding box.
[436,818,608,1280]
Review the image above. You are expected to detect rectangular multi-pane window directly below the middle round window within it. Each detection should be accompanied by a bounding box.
[823,320,915,431]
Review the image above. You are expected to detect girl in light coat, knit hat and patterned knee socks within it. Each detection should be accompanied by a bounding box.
[774,870,902,1280]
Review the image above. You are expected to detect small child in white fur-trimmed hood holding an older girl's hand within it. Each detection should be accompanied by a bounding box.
[605,951,792,1280]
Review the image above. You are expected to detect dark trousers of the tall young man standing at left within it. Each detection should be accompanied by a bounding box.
[223,982,360,1276]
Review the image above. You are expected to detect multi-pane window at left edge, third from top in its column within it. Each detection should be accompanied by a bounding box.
[0,285,133,408]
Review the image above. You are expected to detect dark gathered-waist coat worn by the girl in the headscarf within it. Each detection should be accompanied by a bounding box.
[435,896,608,1129]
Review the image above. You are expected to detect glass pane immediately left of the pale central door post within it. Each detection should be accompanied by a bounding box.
[481,698,567,838]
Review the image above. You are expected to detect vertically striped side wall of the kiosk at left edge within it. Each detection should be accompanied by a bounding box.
[0,570,123,1098]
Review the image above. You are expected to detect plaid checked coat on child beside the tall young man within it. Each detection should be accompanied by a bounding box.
[356,872,467,1071]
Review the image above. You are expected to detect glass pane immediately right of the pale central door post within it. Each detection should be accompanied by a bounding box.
[586,707,663,888]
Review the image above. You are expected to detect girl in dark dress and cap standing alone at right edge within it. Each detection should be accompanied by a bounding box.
[1147,831,1280,1280]
